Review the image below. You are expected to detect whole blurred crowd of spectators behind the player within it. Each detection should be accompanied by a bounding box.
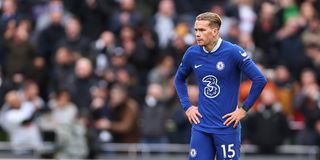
[0,0,320,158]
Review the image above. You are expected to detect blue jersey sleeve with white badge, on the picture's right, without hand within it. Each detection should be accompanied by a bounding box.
[234,46,267,110]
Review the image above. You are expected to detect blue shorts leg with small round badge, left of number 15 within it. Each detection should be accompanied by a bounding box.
[189,129,216,160]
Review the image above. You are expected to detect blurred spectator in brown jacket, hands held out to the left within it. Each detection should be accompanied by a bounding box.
[96,84,139,143]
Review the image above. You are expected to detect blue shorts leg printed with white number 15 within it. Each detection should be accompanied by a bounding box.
[214,134,241,160]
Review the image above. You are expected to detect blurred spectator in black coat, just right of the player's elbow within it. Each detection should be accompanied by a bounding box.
[244,90,289,153]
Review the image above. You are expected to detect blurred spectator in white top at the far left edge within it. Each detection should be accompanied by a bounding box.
[0,91,42,154]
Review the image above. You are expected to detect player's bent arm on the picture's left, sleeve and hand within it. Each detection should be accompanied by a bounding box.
[174,51,202,124]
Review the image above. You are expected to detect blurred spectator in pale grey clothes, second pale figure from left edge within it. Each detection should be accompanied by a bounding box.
[46,90,88,159]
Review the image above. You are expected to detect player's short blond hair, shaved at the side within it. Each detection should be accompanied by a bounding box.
[196,12,222,29]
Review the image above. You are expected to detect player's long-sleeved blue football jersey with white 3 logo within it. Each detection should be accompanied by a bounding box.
[175,38,266,134]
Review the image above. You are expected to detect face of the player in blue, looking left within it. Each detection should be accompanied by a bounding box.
[194,20,218,46]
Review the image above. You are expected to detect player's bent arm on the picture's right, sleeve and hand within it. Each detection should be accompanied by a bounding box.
[223,48,267,128]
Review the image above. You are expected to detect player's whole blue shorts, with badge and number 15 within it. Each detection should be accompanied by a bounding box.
[189,129,241,160]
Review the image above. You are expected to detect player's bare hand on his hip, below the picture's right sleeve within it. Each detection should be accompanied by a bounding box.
[222,106,247,128]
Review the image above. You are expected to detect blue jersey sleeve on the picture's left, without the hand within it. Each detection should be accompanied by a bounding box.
[174,49,192,111]
